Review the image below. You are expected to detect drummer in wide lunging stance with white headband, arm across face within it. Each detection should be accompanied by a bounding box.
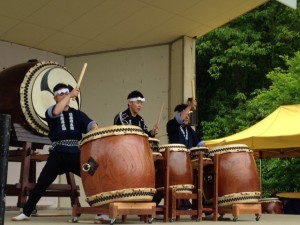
[12,83,98,221]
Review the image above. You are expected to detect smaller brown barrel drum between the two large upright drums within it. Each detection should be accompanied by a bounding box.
[156,144,194,193]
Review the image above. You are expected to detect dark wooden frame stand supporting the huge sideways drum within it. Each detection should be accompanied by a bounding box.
[6,123,80,208]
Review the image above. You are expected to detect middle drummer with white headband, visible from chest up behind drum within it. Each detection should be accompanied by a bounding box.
[114,91,158,137]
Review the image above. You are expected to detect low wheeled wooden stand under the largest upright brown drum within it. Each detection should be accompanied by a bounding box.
[72,202,156,225]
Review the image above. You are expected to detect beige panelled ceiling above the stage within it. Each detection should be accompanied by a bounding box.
[0,0,268,56]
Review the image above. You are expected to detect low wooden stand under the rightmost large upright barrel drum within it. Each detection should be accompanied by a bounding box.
[219,203,262,221]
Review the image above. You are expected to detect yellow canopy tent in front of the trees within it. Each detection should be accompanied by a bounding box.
[206,104,300,158]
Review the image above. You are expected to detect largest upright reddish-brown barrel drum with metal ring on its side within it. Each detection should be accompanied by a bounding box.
[80,126,156,207]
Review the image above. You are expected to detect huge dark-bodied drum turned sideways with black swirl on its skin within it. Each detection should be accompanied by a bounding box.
[0,60,80,135]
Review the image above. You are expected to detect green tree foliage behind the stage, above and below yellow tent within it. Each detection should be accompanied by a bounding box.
[196,0,300,197]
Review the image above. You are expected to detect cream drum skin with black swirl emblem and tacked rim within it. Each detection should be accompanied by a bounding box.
[20,61,81,135]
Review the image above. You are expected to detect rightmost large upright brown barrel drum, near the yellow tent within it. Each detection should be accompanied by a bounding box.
[204,144,261,206]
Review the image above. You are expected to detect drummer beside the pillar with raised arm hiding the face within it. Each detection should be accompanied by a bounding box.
[167,99,205,149]
